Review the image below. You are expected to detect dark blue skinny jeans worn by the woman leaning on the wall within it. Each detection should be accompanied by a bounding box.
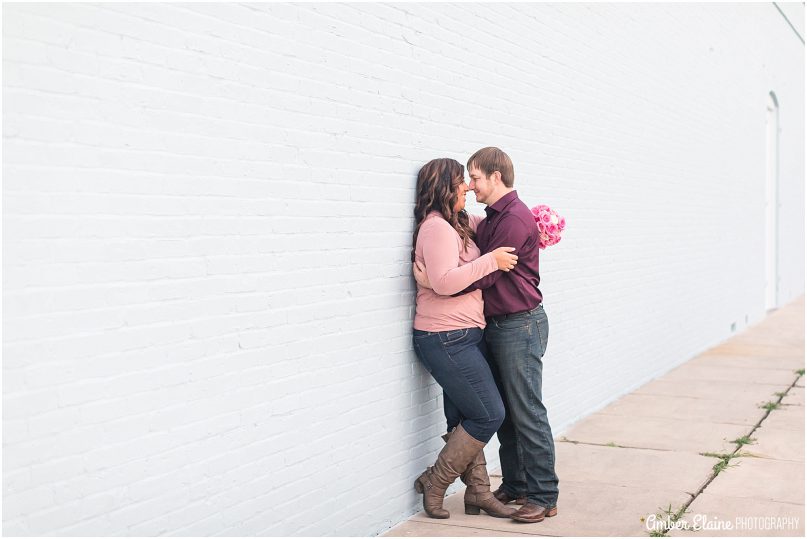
[412,328,504,443]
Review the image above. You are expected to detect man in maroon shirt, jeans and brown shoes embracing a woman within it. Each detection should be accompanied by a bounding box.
[415,147,558,522]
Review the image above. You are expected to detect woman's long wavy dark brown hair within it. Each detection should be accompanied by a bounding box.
[412,157,474,262]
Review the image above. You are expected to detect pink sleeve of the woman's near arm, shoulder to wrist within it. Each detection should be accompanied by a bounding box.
[418,219,498,296]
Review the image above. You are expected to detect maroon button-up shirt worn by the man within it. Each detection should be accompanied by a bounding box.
[469,191,543,316]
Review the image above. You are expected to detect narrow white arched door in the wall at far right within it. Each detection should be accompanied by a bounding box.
[765,92,779,311]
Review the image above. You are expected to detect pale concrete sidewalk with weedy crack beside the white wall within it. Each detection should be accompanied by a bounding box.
[385,296,805,537]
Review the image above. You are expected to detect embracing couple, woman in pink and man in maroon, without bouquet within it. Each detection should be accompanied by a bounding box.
[412,147,558,522]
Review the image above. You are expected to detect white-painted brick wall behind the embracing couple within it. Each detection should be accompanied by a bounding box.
[3,3,804,536]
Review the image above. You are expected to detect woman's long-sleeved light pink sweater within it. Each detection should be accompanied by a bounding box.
[414,211,498,331]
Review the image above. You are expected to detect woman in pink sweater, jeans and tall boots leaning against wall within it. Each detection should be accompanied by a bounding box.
[412,159,518,518]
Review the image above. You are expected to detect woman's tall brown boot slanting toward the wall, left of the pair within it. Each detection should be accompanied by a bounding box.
[415,425,485,518]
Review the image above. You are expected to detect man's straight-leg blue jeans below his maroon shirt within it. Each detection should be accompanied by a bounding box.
[485,305,558,508]
